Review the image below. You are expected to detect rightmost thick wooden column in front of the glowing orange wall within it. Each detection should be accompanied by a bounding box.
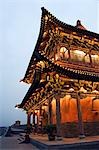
[77,92,85,138]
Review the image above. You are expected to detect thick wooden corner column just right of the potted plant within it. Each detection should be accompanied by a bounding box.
[55,95,62,140]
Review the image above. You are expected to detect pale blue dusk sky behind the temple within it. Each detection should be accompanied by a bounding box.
[0,0,99,126]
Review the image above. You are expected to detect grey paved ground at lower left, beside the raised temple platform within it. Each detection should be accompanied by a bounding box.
[0,135,39,150]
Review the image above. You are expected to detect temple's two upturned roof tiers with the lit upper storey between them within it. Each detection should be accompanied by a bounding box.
[19,8,99,110]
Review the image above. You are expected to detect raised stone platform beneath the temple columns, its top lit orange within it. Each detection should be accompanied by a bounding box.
[30,134,99,150]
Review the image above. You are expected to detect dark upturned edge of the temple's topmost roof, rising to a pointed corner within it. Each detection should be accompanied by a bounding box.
[22,7,99,83]
